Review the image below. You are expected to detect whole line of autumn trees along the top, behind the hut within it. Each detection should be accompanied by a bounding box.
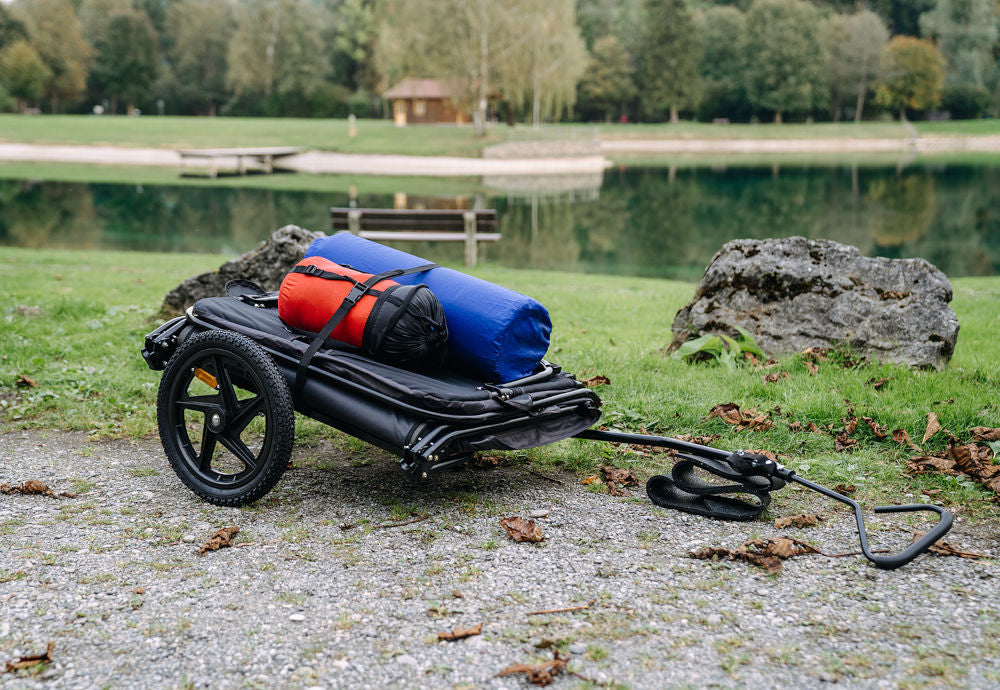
[0,0,1000,123]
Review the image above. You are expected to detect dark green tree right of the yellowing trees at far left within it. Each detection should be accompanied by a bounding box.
[91,10,159,114]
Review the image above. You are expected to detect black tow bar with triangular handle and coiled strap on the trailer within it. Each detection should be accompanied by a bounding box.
[576,429,951,570]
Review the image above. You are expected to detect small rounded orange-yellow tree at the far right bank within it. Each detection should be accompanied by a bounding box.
[875,36,944,122]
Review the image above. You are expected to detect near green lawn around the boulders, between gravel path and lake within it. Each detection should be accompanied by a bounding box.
[0,248,1000,516]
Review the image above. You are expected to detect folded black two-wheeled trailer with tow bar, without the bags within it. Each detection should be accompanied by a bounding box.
[142,298,952,569]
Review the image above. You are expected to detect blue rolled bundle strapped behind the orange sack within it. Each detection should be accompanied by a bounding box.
[306,232,552,383]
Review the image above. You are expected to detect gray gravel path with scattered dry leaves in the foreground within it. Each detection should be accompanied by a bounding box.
[0,432,1000,688]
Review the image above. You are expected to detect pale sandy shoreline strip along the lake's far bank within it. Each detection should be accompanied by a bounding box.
[0,136,1000,177]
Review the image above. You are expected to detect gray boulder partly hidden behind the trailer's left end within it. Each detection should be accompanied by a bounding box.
[163,225,323,314]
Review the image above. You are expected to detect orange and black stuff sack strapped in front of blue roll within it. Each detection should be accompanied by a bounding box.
[278,256,448,366]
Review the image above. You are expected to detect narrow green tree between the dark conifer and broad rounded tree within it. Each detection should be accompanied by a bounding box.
[695,7,750,119]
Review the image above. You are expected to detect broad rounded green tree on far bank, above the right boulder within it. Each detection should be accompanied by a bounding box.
[744,0,828,123]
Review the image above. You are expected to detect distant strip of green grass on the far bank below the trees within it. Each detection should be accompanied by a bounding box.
[0,114,1000,156]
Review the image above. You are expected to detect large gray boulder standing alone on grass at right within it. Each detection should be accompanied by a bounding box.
[669,237,958,369]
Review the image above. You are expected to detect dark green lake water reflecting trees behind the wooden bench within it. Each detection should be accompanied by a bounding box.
[0,163,1000,280]
